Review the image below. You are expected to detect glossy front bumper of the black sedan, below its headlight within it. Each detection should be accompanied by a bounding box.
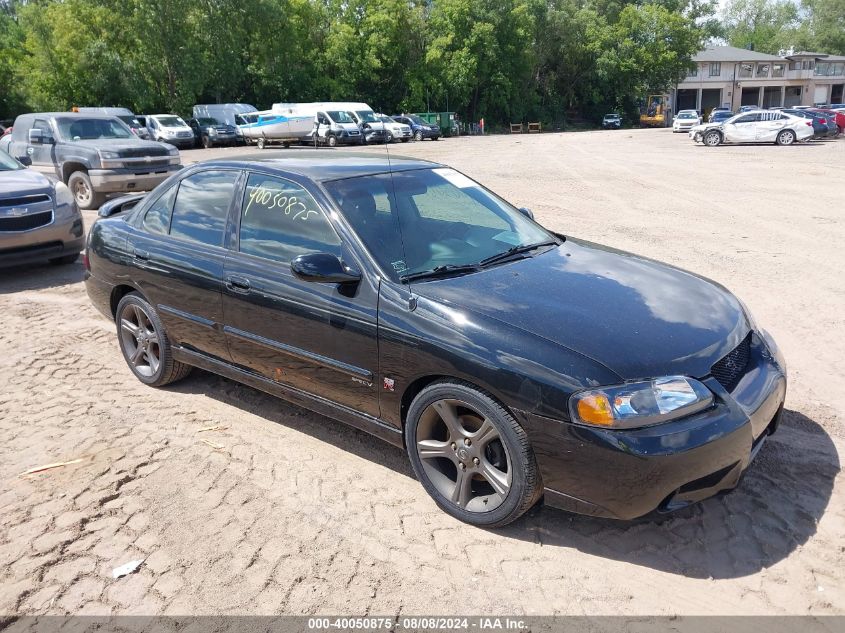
[520,333,786,519]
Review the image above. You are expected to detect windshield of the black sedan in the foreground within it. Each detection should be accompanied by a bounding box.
[325,168,557,281]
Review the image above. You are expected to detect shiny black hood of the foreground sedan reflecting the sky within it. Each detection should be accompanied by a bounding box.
[413,239,749,380]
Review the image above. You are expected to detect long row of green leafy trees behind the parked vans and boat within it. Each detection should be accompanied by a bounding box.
[0,0,845,125]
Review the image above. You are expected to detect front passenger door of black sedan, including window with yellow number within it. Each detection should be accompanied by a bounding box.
[223,171,379,416]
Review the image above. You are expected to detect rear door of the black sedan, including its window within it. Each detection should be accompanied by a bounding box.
[127,168,242,361]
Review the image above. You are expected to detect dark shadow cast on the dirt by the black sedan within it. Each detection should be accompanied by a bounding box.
[170,371,840,578]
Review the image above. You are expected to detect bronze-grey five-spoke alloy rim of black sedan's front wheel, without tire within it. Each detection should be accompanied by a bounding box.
[415,399,513,512]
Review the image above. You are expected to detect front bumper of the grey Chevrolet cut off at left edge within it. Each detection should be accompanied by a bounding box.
[0,214,85,266]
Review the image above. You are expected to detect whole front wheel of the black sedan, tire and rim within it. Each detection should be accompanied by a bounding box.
[405,380,543,528]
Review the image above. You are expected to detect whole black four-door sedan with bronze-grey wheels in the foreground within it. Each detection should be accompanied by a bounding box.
[86,150,786,526]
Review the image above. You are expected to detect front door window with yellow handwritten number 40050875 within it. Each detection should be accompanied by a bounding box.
[239,173,341,263]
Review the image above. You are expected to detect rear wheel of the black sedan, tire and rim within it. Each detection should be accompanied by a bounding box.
[114,292,192,387]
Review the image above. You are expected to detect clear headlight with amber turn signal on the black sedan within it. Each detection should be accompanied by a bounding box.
[569,376,713,429]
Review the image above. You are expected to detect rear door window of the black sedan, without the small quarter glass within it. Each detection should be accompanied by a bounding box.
[170,171,238,246]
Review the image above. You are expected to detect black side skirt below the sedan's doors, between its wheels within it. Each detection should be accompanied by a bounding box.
[173,347,405,450]
